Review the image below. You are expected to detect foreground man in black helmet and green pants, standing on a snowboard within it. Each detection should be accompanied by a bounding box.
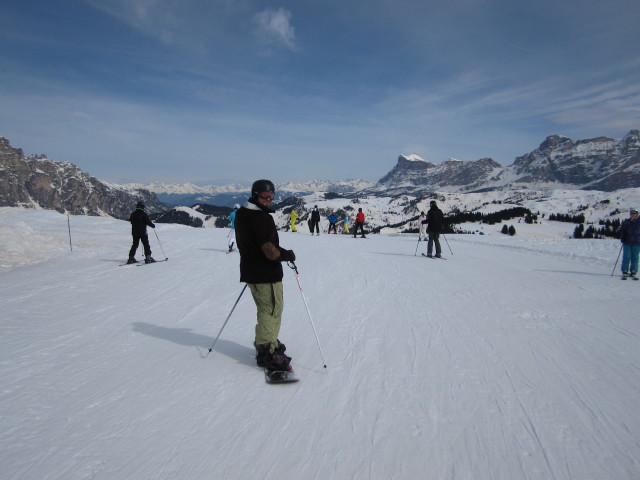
[236,180,296,371]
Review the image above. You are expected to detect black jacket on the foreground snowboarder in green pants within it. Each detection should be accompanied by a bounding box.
[235,201,282,283]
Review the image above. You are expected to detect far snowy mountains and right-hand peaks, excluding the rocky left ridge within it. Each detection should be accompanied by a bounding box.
[125,130,640,206]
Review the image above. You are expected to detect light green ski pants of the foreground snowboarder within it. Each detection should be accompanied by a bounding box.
[247,282,284,353]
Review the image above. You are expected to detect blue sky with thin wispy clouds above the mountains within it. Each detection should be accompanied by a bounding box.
[0,0,640,183]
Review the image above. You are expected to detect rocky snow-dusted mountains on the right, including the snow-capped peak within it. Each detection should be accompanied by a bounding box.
[371,130,640,194]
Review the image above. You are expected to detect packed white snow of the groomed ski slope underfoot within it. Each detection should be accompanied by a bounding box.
[0,208,640,480]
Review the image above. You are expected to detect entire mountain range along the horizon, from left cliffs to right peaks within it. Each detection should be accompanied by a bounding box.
[0,130,640,218]
